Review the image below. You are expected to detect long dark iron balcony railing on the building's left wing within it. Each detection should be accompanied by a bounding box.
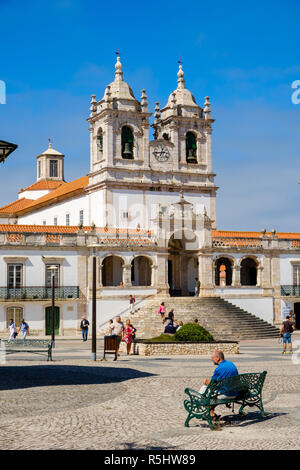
[0,286,79,300]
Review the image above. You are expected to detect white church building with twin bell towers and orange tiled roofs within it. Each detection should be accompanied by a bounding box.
[0,57,300,334]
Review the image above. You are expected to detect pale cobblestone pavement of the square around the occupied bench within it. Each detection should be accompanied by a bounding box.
[0,333,300,450]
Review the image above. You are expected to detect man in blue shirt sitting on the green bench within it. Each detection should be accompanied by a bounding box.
[199,351,239,421]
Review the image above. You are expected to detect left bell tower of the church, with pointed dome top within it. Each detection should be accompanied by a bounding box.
[88,56,151,185]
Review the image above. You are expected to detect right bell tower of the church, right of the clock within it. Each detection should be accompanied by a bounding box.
[150,63,218,228]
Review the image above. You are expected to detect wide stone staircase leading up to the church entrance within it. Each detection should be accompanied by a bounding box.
[122,297,279,340]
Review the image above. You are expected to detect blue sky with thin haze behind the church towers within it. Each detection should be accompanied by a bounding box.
[0,0,300,232]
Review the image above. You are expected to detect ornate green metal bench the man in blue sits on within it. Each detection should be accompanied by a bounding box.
[184,371,267,429]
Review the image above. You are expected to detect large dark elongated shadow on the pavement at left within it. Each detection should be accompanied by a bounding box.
[0,365,156,391]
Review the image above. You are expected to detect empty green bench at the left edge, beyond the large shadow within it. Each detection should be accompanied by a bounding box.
[1,339,52,361]
